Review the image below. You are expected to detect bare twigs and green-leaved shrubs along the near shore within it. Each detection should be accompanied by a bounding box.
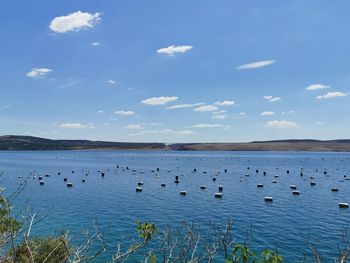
[0,175,350,263]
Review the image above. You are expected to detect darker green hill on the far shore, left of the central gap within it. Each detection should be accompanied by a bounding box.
[0,135,165,150]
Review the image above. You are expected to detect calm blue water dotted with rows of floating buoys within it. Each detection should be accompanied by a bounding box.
[0,151,350,262]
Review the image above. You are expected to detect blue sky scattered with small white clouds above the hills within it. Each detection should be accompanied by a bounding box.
[0,0,350,143]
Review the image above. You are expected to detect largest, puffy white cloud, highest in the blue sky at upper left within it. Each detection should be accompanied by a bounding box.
[50,11,101,33]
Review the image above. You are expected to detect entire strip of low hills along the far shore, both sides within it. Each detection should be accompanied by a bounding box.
[0,135,350,152]
